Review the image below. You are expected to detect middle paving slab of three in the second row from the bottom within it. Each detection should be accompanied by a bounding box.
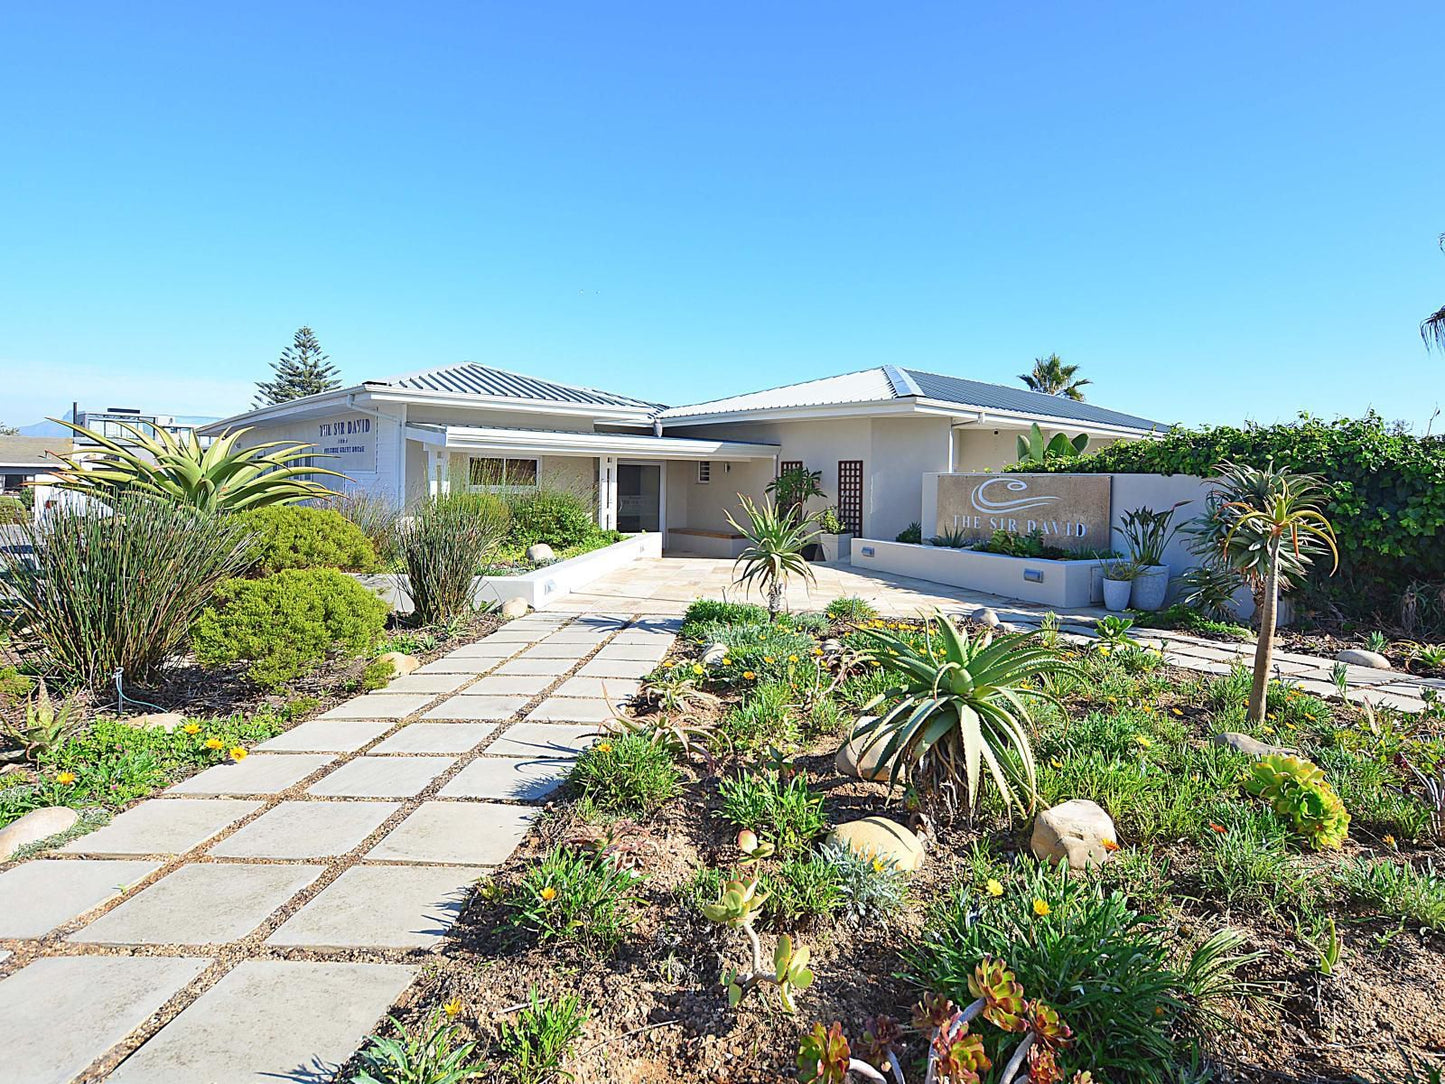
[68,863,327,945]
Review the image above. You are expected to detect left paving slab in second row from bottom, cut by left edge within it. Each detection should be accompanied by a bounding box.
[0,859,162,936]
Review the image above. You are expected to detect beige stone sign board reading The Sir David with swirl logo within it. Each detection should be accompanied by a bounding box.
[933,474,1113,549]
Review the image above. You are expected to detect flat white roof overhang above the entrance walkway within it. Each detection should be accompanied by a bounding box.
[406,425,779,460]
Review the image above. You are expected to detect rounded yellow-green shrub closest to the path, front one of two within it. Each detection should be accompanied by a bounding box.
[191,568,390,688]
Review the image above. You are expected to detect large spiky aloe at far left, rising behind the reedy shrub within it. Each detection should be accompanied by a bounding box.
[52,419,347,512]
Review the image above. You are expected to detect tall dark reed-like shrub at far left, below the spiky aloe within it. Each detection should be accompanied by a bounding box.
[0,494,253,689]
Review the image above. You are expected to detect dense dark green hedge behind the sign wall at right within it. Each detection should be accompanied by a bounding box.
[1027,412,1445,619]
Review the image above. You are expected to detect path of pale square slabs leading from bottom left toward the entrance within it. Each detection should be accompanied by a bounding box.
[0,607,678,1084]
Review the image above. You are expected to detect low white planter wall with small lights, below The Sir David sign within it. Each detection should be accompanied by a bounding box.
[853,538,1100,608]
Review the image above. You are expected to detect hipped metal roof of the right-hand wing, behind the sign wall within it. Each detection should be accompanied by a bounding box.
[657,366,1168,431]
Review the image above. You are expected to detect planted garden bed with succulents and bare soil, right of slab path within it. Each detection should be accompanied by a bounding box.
[358,604,1445,1084]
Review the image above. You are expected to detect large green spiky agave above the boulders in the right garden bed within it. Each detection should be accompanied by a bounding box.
[854,614,1074,812]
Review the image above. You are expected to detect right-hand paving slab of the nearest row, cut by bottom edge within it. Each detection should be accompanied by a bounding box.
[108,960,418,1084]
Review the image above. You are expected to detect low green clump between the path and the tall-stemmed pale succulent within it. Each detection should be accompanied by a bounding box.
[507,847,640,958]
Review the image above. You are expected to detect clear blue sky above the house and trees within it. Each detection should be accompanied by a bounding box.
[0,1,1445,431]
